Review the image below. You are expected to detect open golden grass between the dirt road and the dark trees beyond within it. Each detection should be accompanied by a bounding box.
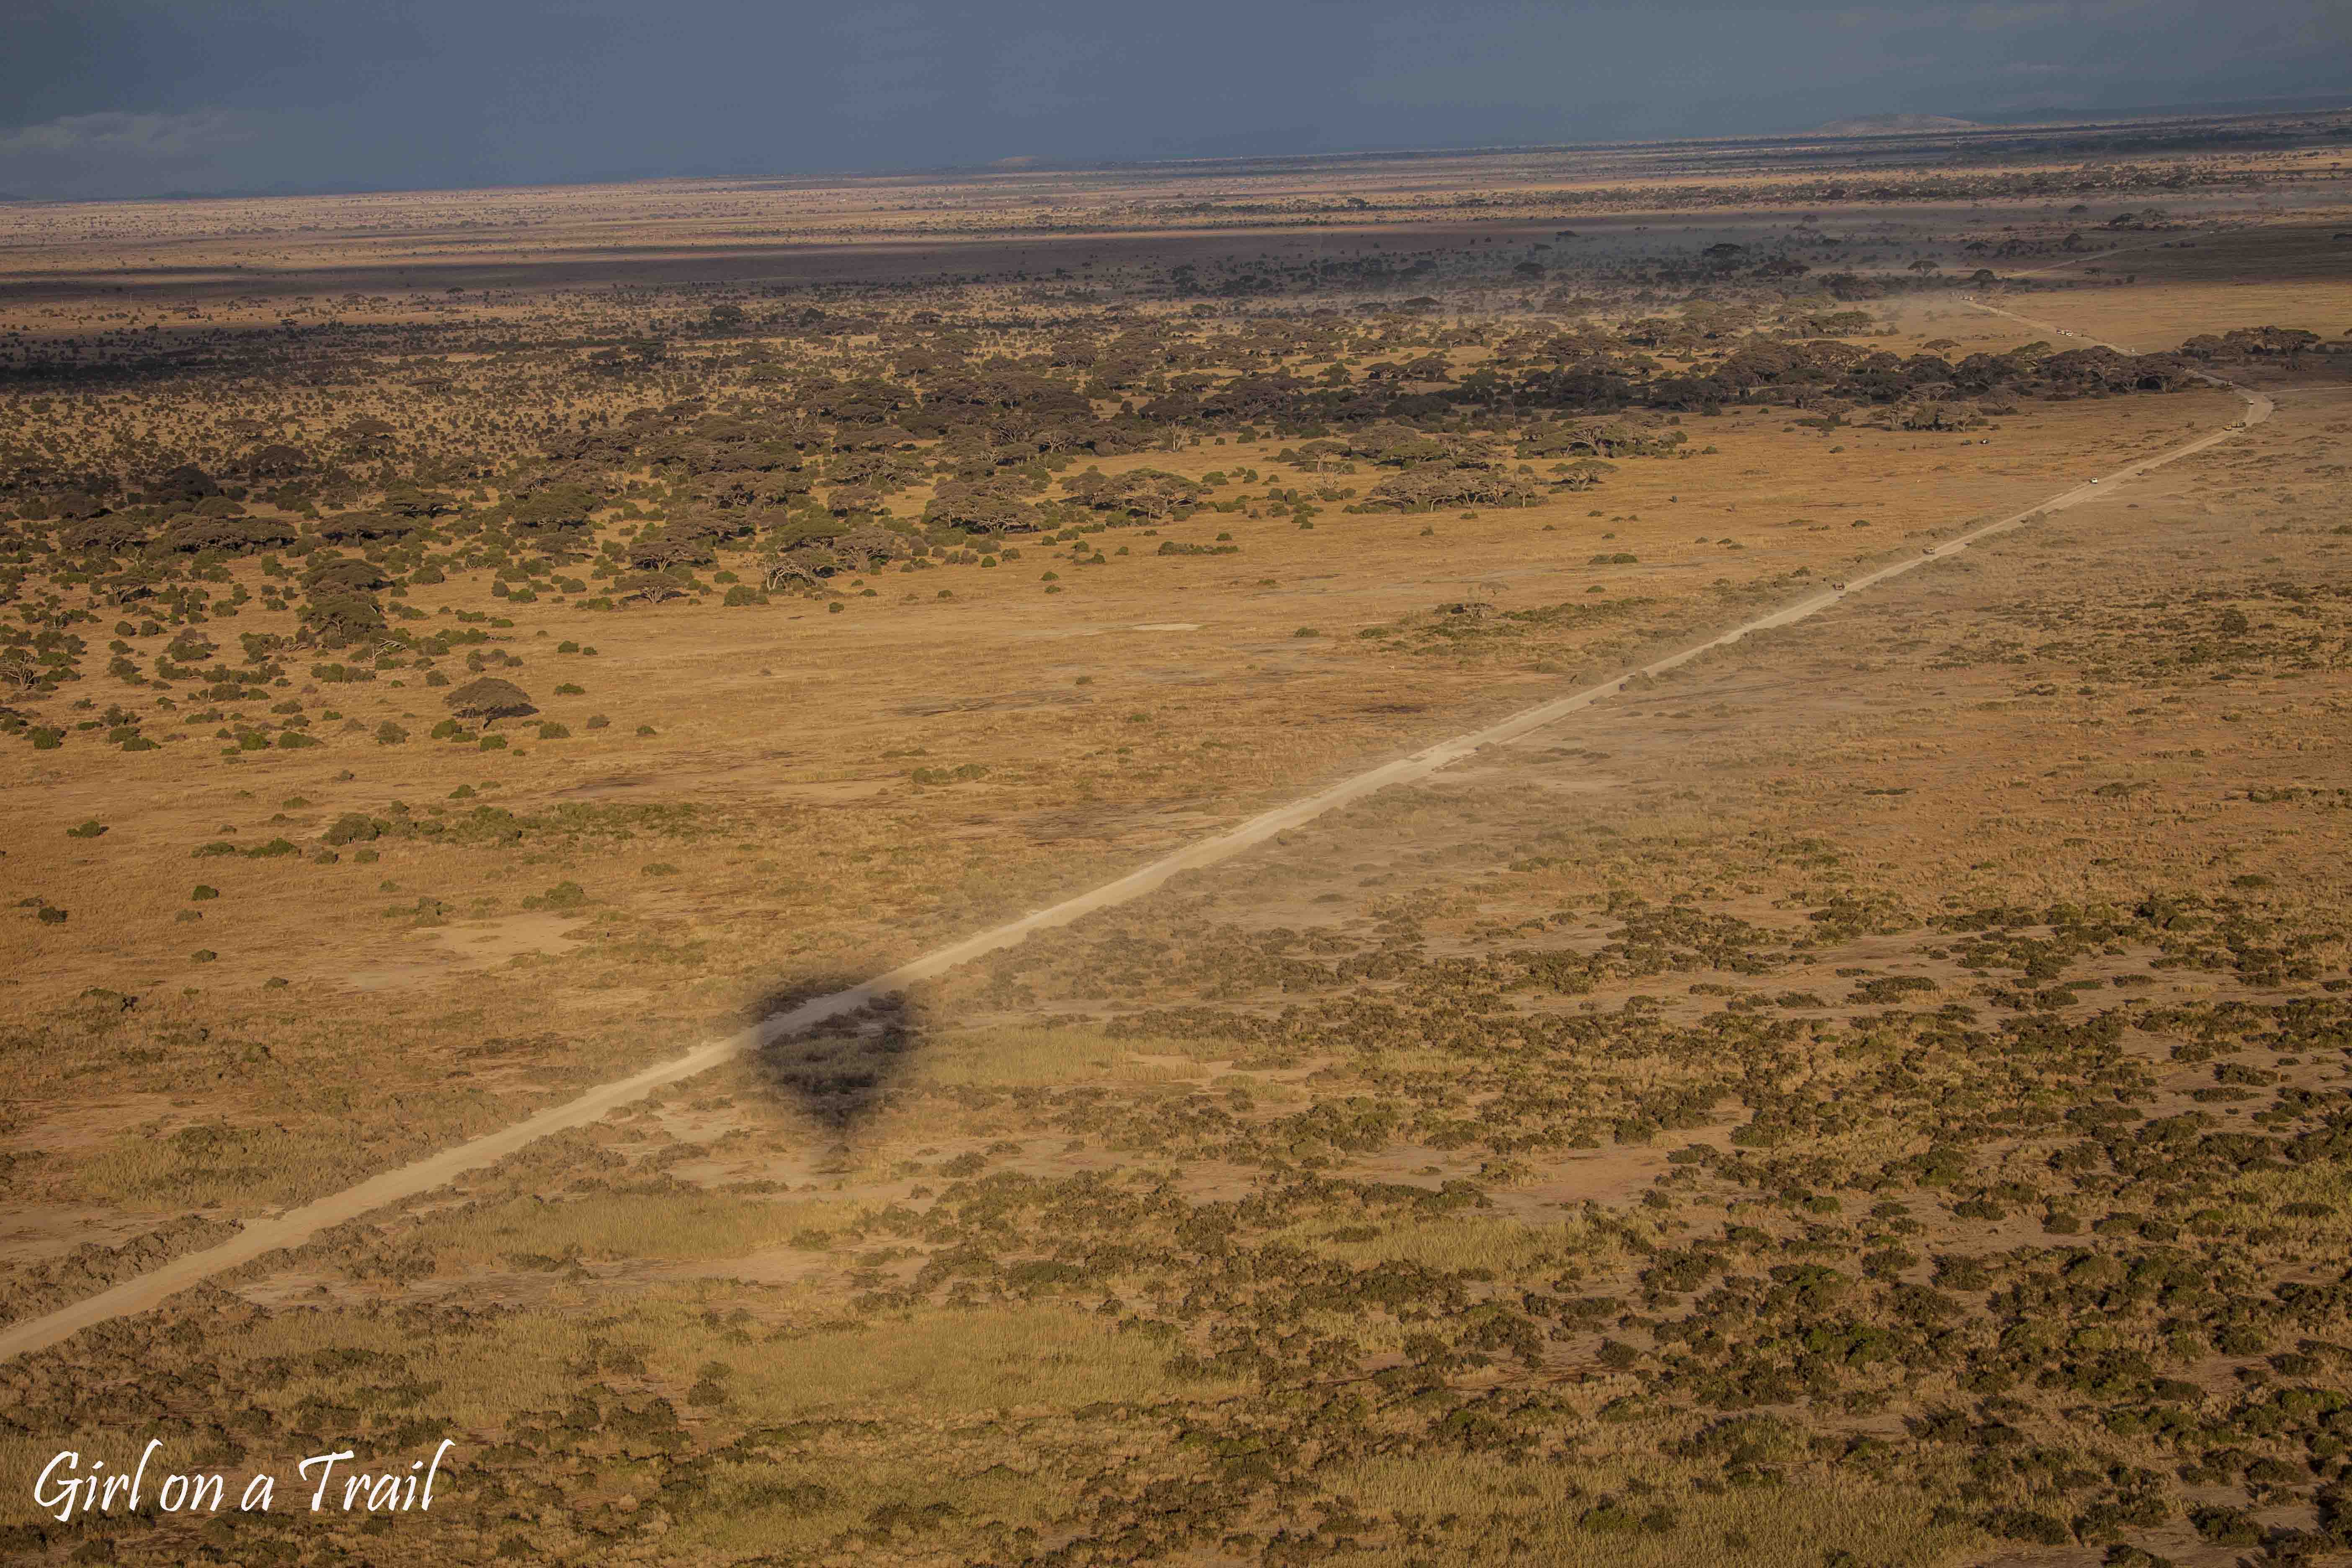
[0,381,2227,1241]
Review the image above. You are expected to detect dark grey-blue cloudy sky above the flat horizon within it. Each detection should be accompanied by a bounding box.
[0,0,2352,200]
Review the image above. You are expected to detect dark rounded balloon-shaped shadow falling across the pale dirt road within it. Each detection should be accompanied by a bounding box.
[743,975,929,1159]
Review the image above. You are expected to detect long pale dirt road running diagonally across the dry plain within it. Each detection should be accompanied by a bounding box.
[0,315,2272,1359]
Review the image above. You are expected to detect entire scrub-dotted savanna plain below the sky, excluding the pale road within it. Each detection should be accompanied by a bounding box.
[0,115,2352,1568]
